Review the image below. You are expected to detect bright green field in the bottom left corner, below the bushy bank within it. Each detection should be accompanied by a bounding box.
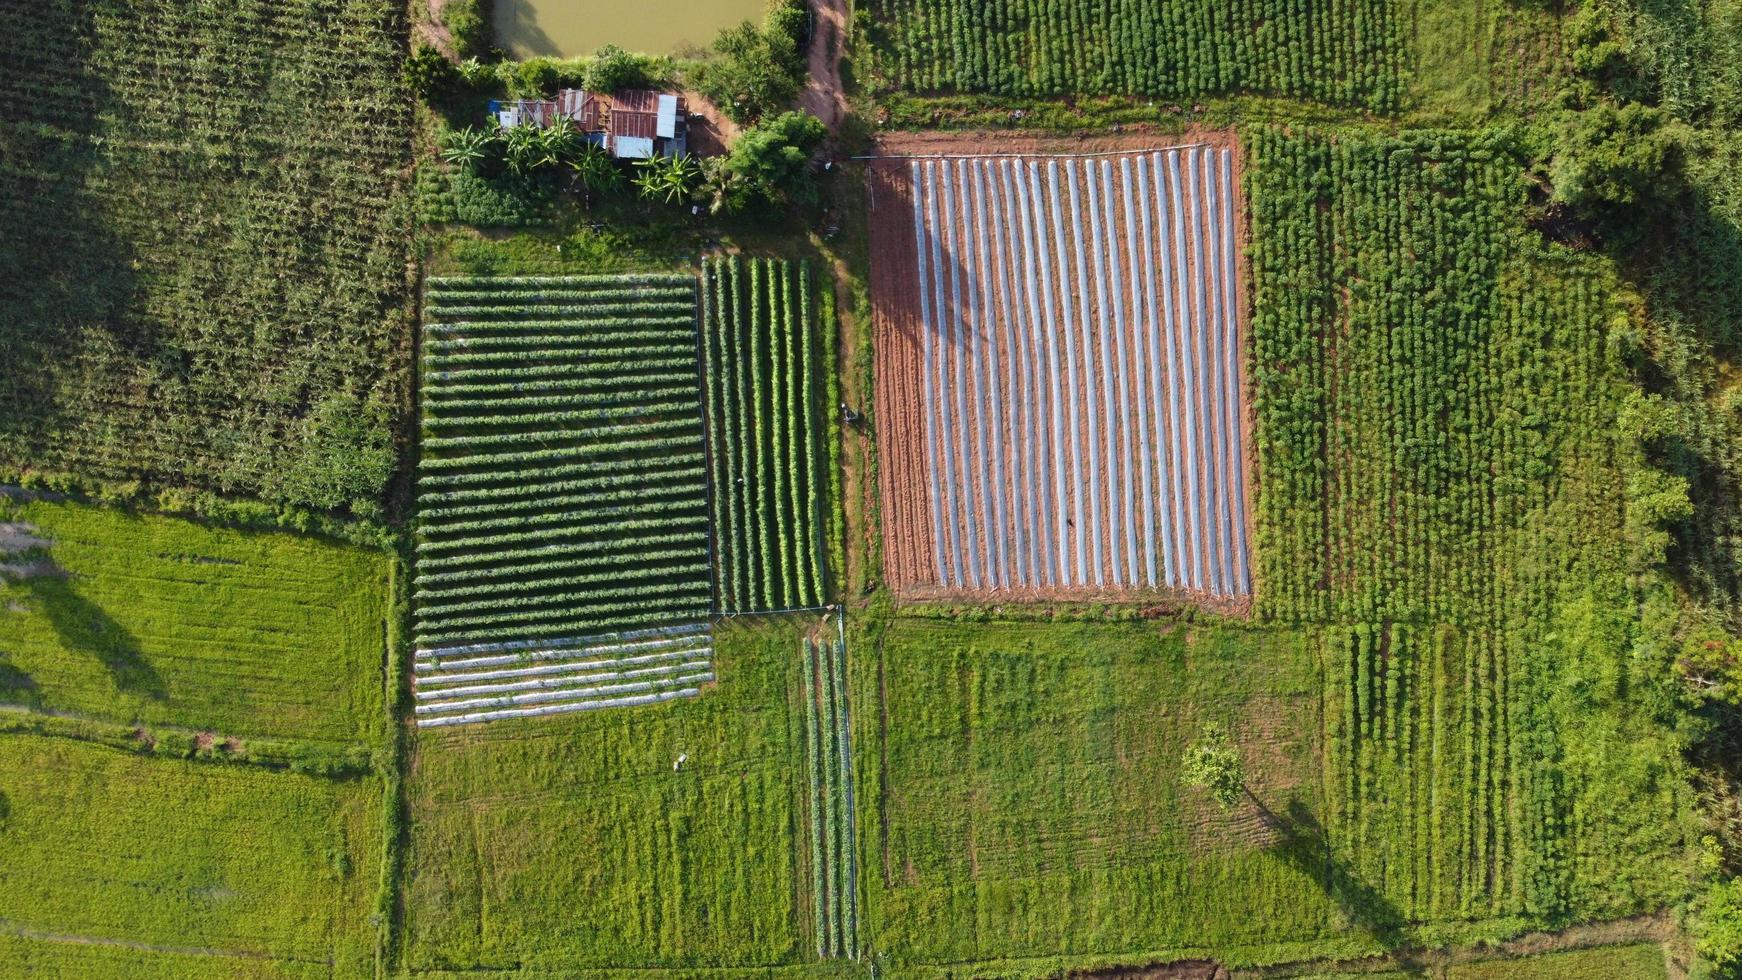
[0,735,381,977]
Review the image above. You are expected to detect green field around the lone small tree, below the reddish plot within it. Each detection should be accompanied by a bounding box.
[854,620,1351,973]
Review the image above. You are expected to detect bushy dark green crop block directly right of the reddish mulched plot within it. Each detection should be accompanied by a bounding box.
[1252,132,1611,623]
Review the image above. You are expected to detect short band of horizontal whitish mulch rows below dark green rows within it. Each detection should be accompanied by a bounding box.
[413,623,714,728]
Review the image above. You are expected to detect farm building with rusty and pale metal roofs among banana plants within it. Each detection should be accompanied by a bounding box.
[490,89,688,160]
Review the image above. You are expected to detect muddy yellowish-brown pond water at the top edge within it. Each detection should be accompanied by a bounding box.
[496,0,766,57]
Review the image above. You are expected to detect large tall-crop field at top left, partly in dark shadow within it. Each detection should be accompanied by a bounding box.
[0,0,411,510]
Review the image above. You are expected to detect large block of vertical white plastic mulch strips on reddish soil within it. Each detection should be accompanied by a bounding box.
[909,148,1252,595]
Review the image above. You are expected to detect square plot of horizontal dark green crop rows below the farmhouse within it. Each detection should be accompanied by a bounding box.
[416,275,712,651]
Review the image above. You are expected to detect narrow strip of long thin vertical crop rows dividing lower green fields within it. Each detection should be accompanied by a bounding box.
[803,637,859,959]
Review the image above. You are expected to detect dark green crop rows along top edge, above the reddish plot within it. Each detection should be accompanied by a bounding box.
[869,0,1408,110]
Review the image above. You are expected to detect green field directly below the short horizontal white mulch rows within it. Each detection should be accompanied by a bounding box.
[401,620,814,971]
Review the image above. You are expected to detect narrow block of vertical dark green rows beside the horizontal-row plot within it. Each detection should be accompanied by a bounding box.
[702,256,833,613]
